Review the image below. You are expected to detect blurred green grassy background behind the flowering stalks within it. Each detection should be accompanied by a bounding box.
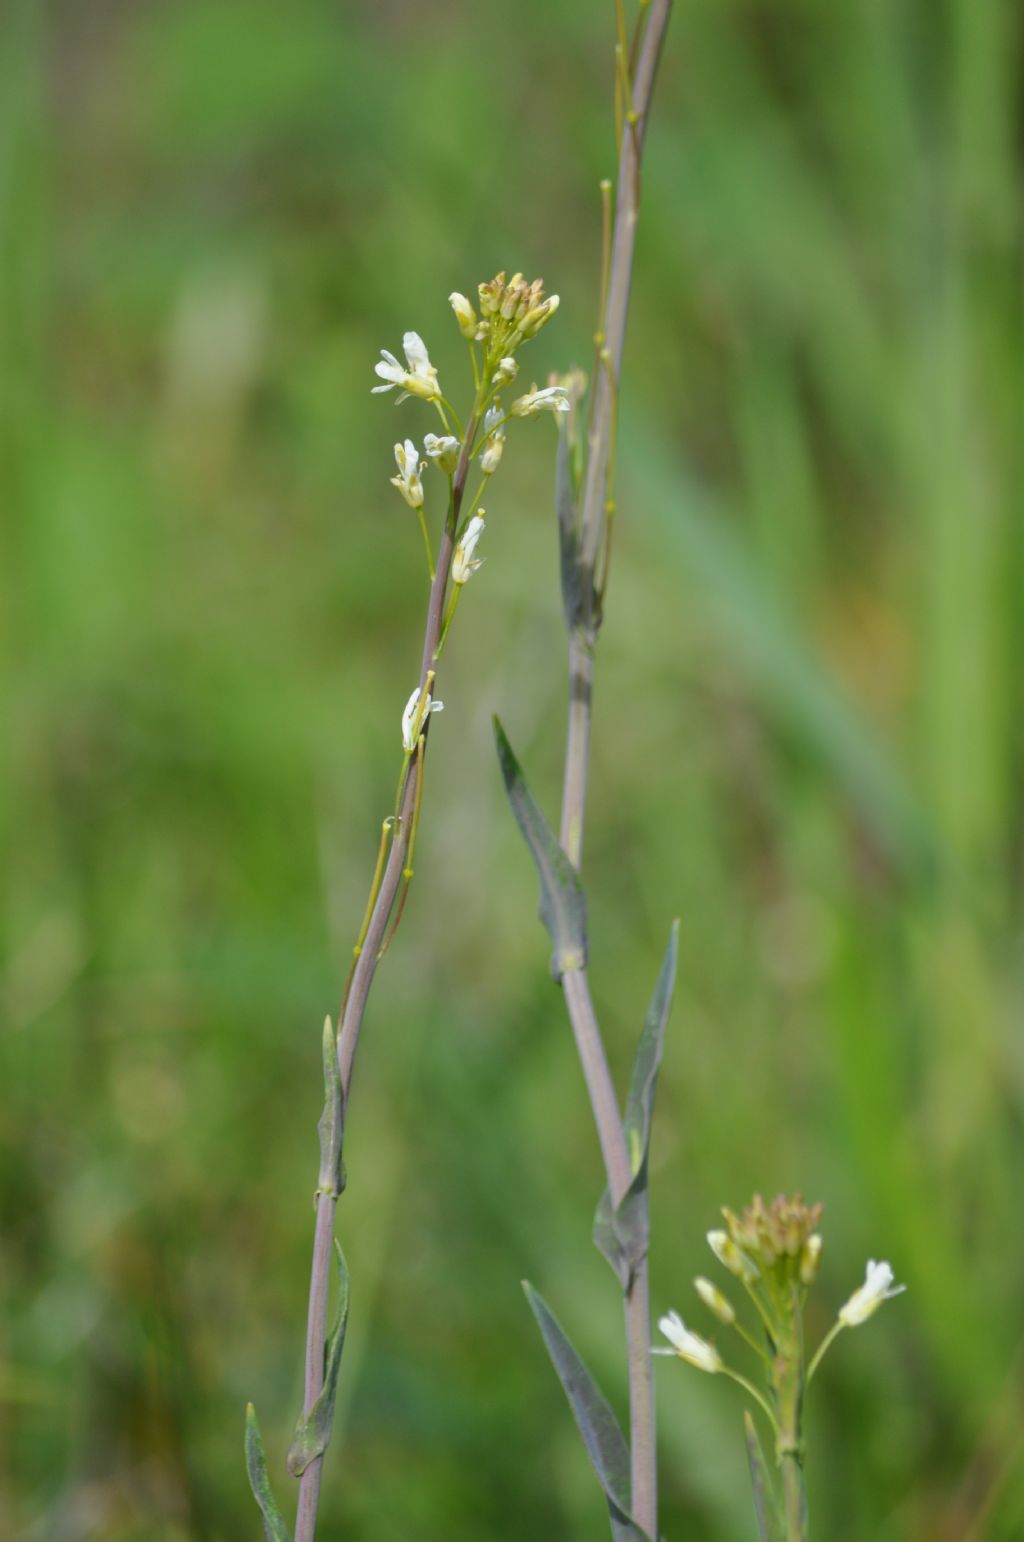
[0,0,1024,1542]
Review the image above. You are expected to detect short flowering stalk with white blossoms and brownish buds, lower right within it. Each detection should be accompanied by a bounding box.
[652,1195,905,1542]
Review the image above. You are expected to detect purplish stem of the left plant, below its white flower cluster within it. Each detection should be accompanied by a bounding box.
[295,416,477,1542]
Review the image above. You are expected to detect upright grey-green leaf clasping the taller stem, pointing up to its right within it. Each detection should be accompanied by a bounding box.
[594,921,679,1289]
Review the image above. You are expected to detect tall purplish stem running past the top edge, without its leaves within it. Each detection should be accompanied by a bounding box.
[560,0,671,1537]
